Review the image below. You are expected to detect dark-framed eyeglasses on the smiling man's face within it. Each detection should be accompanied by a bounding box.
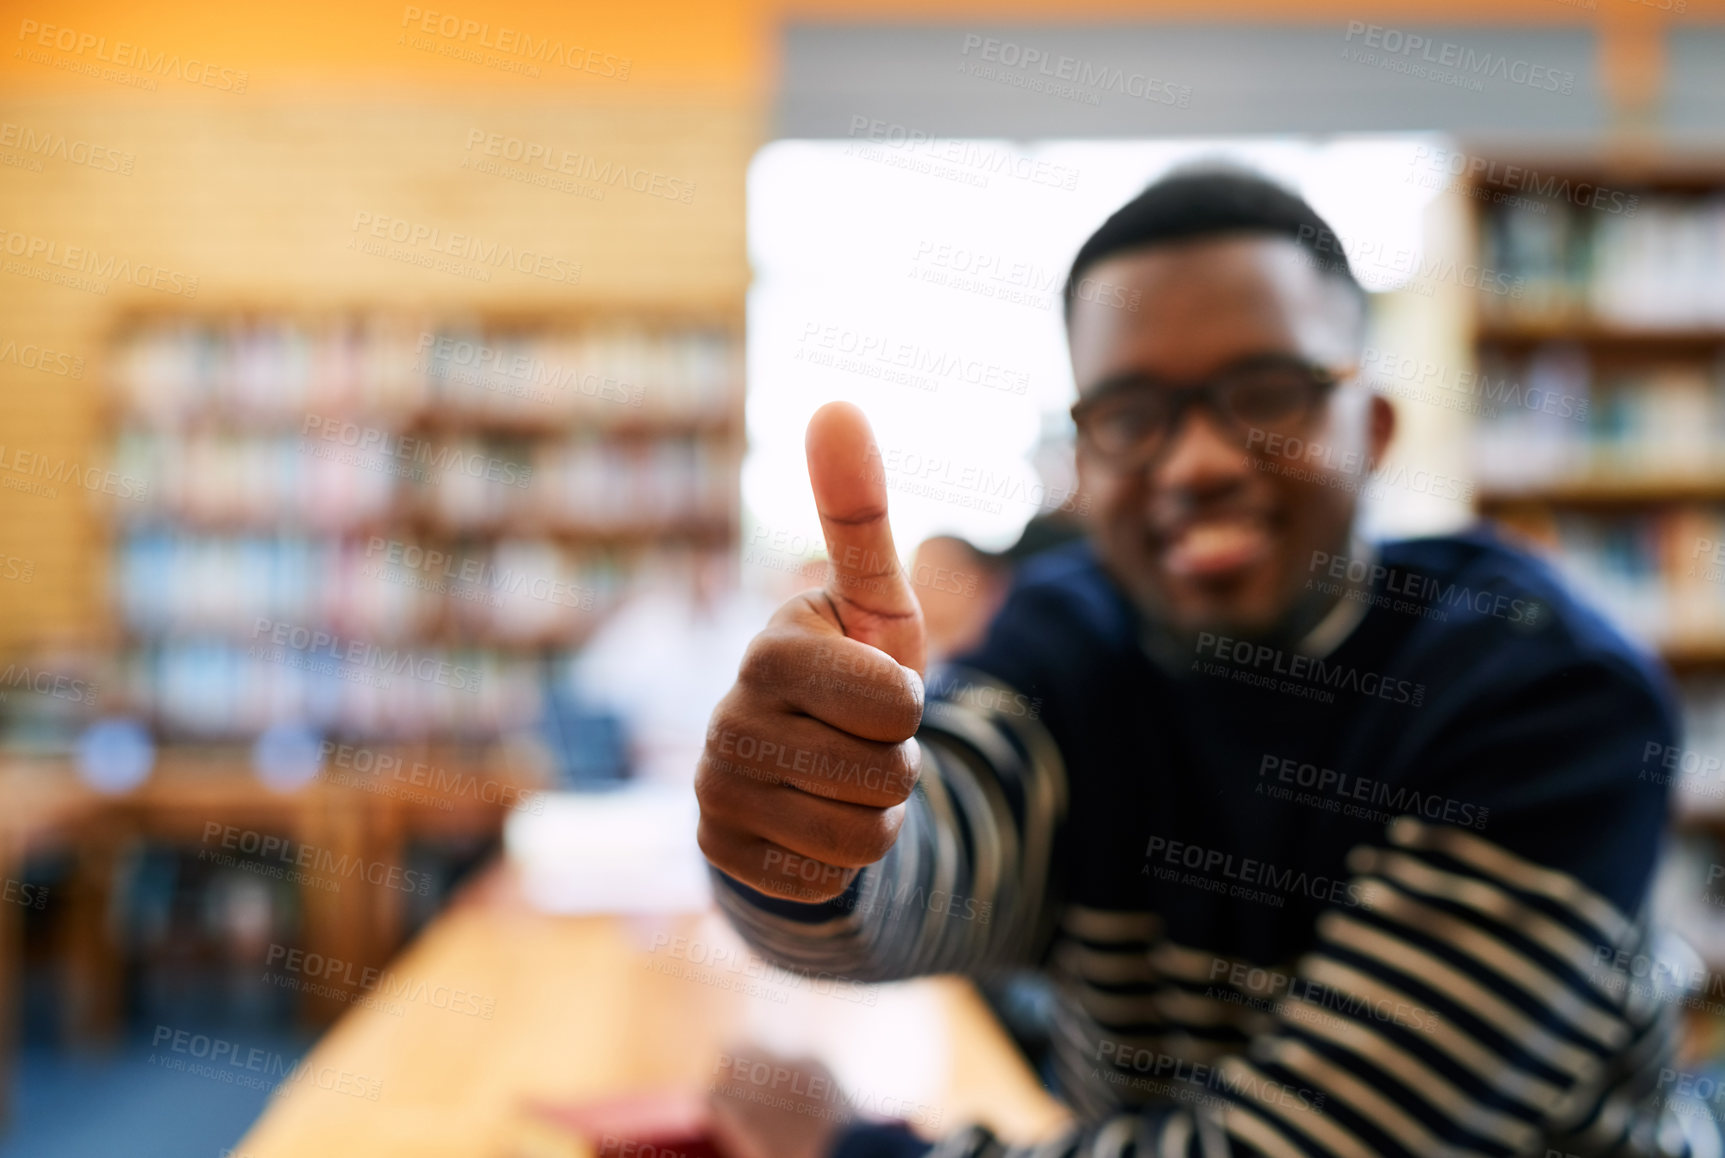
[1071,354,1352,469]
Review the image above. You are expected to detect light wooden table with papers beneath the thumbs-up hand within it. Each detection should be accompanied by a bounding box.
[235,870,1068,1158]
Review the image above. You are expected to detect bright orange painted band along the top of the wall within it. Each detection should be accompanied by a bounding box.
[0,0,1704,100]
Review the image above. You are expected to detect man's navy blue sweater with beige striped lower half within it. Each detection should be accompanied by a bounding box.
[719,532,1692,1158]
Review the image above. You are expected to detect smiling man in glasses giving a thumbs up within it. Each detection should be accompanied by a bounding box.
[697,173,1709,1158]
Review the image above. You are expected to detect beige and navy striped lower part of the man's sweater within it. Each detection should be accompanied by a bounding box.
[719,677,1718,1158]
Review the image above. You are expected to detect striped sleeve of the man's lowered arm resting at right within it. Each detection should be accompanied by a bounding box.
[933,816,1718,1158]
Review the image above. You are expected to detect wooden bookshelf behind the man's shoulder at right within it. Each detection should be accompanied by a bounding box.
[1471,164,1725,968]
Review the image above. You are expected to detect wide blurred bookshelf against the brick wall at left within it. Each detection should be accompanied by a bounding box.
[102,312,742,742]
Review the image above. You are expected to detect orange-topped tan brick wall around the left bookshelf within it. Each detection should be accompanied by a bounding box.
[0,0,1704,651]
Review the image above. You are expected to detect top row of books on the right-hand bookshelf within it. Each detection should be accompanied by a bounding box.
[1482,193,1725,330]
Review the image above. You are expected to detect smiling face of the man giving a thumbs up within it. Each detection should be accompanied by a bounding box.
[1070,236,1394,637]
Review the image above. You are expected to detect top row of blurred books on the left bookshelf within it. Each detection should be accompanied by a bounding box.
[114,318,740,428]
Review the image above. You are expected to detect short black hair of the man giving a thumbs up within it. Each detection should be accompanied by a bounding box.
[1066,164,1366,319]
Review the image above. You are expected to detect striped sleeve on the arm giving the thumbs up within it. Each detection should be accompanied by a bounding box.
[716,668,1066,980]
